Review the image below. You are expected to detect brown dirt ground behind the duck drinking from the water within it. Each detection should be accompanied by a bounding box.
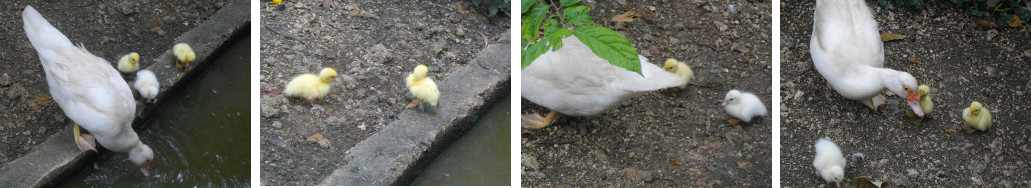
[0,0,226,166]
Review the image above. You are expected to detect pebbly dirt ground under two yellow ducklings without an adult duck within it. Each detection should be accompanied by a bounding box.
[260,0,509,185]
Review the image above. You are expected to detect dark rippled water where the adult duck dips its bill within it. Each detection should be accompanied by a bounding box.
[60,36,251,187]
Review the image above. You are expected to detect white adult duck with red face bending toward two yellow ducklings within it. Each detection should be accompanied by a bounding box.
[809,0,924,117]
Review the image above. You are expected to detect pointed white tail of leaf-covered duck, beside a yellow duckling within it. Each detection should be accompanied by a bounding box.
[620,56,688,92]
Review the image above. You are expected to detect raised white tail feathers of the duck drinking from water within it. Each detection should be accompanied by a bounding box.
[22,6,74,51]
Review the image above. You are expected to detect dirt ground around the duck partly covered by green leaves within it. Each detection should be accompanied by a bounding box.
[522,0,772,187]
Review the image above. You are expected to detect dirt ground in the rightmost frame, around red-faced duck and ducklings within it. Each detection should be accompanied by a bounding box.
[779,1,1031,187]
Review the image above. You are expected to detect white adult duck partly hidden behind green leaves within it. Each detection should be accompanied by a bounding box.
[522,36,687,128]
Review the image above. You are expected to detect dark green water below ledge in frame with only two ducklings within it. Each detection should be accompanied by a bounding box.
[412,96,511,186]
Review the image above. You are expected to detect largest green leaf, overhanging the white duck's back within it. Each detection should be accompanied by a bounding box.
[573,25,643,75]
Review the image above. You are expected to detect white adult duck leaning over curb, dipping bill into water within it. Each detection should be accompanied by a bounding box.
[22,6,154,176]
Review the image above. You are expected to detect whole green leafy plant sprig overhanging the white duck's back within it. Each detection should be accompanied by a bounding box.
[521,0,641,74]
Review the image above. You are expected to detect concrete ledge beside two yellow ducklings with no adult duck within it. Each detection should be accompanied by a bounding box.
[322,31,511,186]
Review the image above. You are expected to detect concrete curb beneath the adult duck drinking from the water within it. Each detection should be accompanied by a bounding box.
[0,0,251,187]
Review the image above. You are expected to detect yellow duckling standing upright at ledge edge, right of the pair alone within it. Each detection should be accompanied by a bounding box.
[404,64,440,111]
